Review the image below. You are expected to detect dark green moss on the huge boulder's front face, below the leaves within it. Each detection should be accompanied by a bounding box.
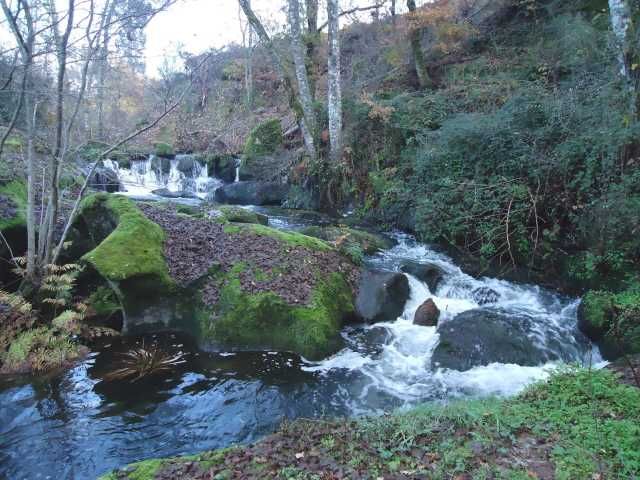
[201,264,353,359]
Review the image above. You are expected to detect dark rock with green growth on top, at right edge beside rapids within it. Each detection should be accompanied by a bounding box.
[578,285,640,360]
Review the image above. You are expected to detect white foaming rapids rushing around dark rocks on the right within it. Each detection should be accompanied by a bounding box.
[303,234,602,404]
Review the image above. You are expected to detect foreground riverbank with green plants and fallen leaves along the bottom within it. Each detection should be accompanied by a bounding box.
[101,369,640,480]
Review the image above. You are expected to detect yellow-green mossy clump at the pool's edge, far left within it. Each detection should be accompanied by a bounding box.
[2,327,79,373]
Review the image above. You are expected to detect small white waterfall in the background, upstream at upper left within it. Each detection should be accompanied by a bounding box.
[103,154,222,199]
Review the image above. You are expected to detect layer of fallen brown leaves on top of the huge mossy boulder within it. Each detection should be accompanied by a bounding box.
[140,204,358,305]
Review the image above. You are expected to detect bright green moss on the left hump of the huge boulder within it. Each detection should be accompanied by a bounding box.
[80,193,173,287]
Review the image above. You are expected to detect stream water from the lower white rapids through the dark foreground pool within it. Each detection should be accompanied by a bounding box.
[0,202,601,479]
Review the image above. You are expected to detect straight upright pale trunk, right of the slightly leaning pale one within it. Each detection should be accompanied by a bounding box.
[327,0,342,162]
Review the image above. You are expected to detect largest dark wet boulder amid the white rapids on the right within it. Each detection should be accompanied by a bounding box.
[431,309,559,371]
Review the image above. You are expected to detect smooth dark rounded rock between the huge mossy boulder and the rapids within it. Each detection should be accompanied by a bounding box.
[356,271,410,323]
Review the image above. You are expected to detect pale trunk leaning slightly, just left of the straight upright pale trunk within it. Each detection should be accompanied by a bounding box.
[289,0,318,158]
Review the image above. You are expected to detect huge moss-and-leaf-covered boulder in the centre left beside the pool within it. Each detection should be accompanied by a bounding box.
[72,194,357,359]
